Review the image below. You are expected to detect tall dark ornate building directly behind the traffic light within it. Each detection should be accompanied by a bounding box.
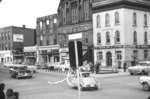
[58,0,93,61]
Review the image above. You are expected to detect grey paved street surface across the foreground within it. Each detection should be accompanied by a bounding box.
[0,69,150,99]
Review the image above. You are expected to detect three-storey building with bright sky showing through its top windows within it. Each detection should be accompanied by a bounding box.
[34,14,60,63]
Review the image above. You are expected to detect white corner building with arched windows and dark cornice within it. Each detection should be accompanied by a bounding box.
[93,0,150,68]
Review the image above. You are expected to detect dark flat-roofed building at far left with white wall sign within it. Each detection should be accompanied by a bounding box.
[0,25,36,63]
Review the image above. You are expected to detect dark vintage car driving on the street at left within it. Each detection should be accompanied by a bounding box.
[9,65,32,79]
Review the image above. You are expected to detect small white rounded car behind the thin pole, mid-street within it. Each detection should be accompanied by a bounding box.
[67,72,98,90]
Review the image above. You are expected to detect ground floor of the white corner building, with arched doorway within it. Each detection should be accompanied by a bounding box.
[94,46,150,68]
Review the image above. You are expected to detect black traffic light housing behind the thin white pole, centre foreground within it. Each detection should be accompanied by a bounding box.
[69,41,83,70]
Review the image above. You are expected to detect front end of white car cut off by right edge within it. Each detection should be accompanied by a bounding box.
[139,76,150,91]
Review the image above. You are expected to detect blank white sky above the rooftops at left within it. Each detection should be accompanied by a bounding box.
[0,0,60,28]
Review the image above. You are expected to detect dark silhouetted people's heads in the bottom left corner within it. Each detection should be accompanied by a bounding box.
[0,83,19,99]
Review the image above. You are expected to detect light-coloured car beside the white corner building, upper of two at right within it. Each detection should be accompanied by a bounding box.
[128,61,150,75]
